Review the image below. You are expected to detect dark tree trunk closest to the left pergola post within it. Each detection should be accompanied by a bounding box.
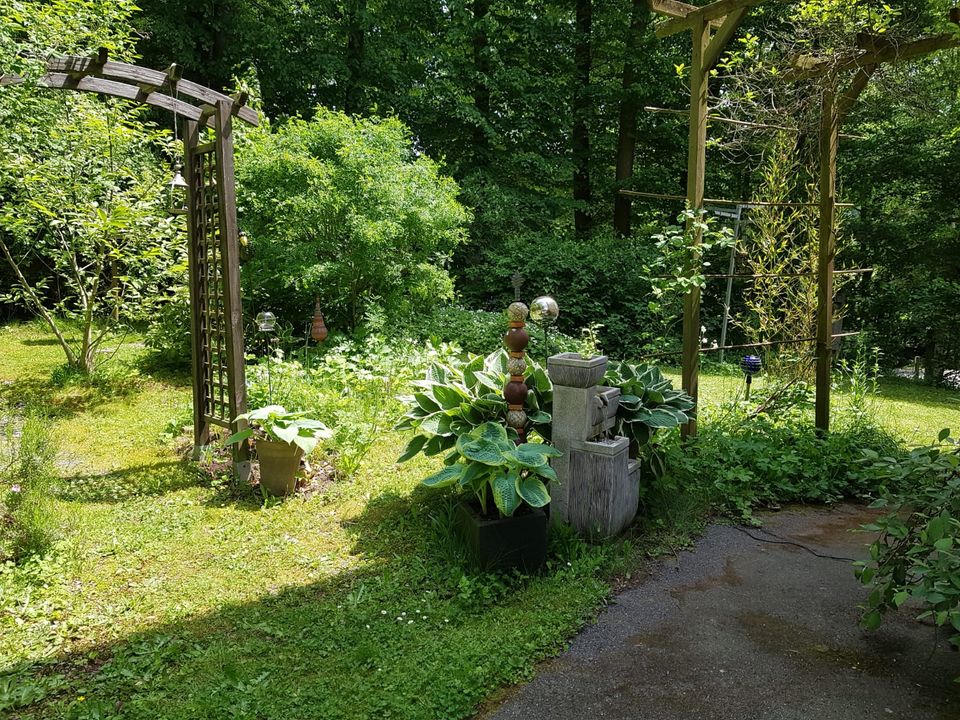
[613,0,650,236]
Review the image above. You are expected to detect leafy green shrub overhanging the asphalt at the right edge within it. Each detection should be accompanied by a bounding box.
[856,429,960,647]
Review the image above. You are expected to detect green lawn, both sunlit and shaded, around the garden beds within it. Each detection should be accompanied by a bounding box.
[0,325,960,720]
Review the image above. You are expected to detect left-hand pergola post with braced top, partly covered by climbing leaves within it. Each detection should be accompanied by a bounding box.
[650,0,763,436]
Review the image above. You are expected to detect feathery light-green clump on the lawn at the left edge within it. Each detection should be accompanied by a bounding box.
[0,411,57,562]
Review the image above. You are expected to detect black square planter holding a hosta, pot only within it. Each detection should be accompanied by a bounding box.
[457,503,547,573]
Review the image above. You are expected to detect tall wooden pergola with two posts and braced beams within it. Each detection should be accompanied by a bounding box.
[621,0,960,436]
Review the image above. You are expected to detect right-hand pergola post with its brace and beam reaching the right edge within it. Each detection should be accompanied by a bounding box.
[787,26,960,433]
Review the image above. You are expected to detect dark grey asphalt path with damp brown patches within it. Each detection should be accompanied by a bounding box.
[483,505,960,720]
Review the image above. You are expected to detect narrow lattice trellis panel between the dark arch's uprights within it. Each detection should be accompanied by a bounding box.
[189,143,232,428]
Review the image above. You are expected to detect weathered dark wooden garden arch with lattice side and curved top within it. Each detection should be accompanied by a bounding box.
[0,49,259,477]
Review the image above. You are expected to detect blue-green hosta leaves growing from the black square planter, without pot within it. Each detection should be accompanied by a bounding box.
[423,422,562,517]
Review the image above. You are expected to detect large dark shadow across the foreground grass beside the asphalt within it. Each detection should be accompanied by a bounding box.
[0,486,544,720]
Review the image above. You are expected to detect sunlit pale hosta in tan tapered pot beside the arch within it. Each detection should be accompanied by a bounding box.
[226,405,333,496]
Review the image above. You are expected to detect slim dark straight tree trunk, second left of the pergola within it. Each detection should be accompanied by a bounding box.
[573,0,593,237]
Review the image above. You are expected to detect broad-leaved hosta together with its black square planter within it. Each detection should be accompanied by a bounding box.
[423,422,561,572]
